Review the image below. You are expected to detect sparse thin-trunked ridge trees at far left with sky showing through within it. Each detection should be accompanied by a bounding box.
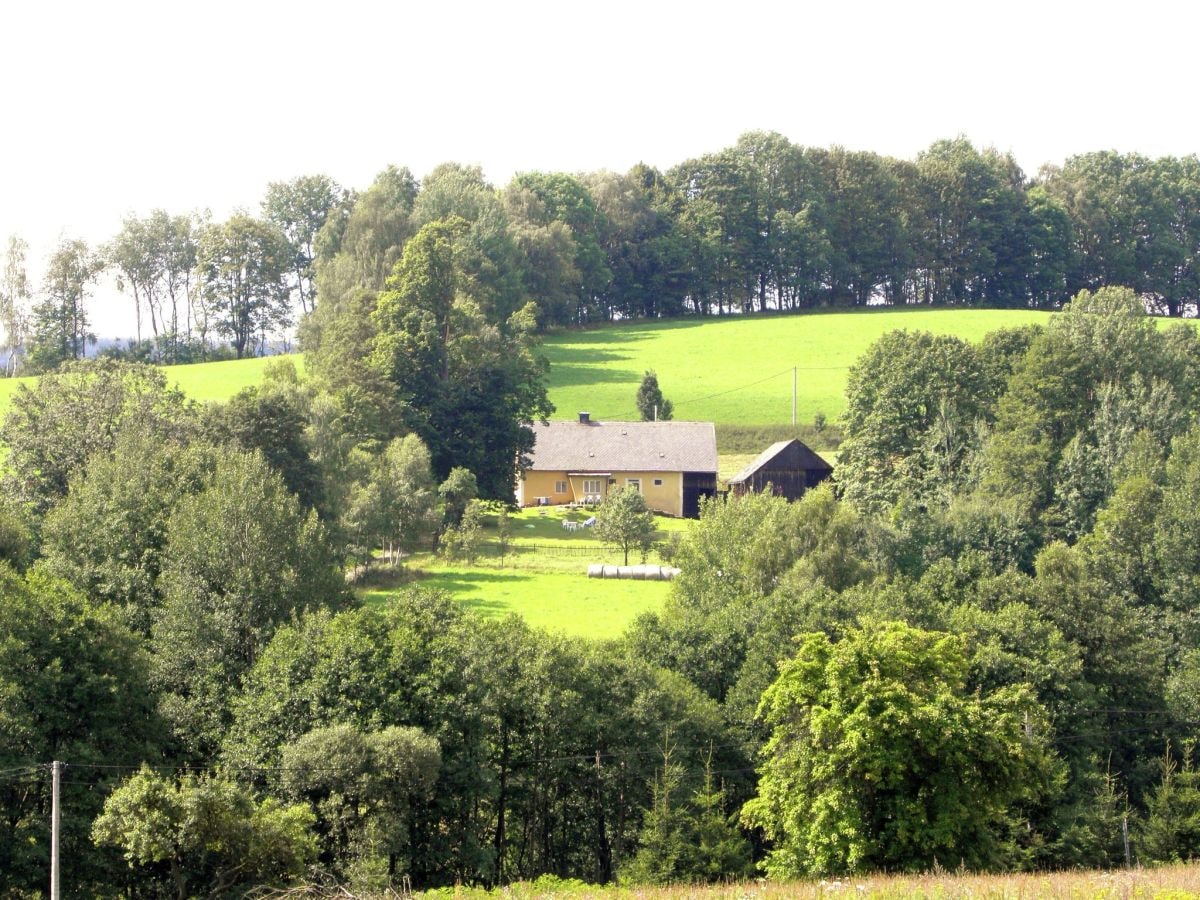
[0,176,346,374]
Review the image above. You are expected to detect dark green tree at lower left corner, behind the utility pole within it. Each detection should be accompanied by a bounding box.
[0,565,164,895]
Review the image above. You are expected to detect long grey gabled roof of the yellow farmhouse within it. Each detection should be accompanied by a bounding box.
[529,421,716,473]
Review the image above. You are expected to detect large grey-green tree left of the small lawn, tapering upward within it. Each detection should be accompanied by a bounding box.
[152,452,346,757]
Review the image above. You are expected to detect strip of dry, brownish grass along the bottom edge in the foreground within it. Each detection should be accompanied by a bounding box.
[418,863,1200,900]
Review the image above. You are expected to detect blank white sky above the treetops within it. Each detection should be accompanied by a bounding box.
[0,0,1200,334]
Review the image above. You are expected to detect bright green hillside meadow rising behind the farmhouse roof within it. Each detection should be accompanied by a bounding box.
[542,310,1050,425]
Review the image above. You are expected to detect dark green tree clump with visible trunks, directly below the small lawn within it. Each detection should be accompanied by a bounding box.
[226,592,744,884]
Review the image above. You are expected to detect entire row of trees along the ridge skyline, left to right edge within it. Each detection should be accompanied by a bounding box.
[9,132,1200,370]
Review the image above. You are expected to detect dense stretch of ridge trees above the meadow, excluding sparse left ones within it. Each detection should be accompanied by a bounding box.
[317,139,1200,336]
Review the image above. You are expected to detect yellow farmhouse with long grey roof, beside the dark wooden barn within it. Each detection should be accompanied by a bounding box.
[516,413,716,517]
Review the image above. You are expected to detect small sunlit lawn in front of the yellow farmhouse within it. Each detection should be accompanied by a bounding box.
[360,508,688,640]
